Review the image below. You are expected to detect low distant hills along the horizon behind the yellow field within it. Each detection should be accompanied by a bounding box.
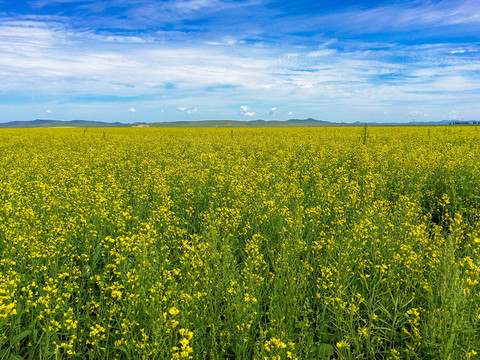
[0,118,480,128]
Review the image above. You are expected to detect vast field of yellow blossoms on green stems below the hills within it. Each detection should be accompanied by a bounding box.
[0,126,480,360]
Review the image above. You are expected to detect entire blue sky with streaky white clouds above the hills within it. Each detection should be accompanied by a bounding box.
[0,0,480,122]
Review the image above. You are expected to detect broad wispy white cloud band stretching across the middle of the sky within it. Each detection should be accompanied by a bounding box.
[0,16,480,104]
